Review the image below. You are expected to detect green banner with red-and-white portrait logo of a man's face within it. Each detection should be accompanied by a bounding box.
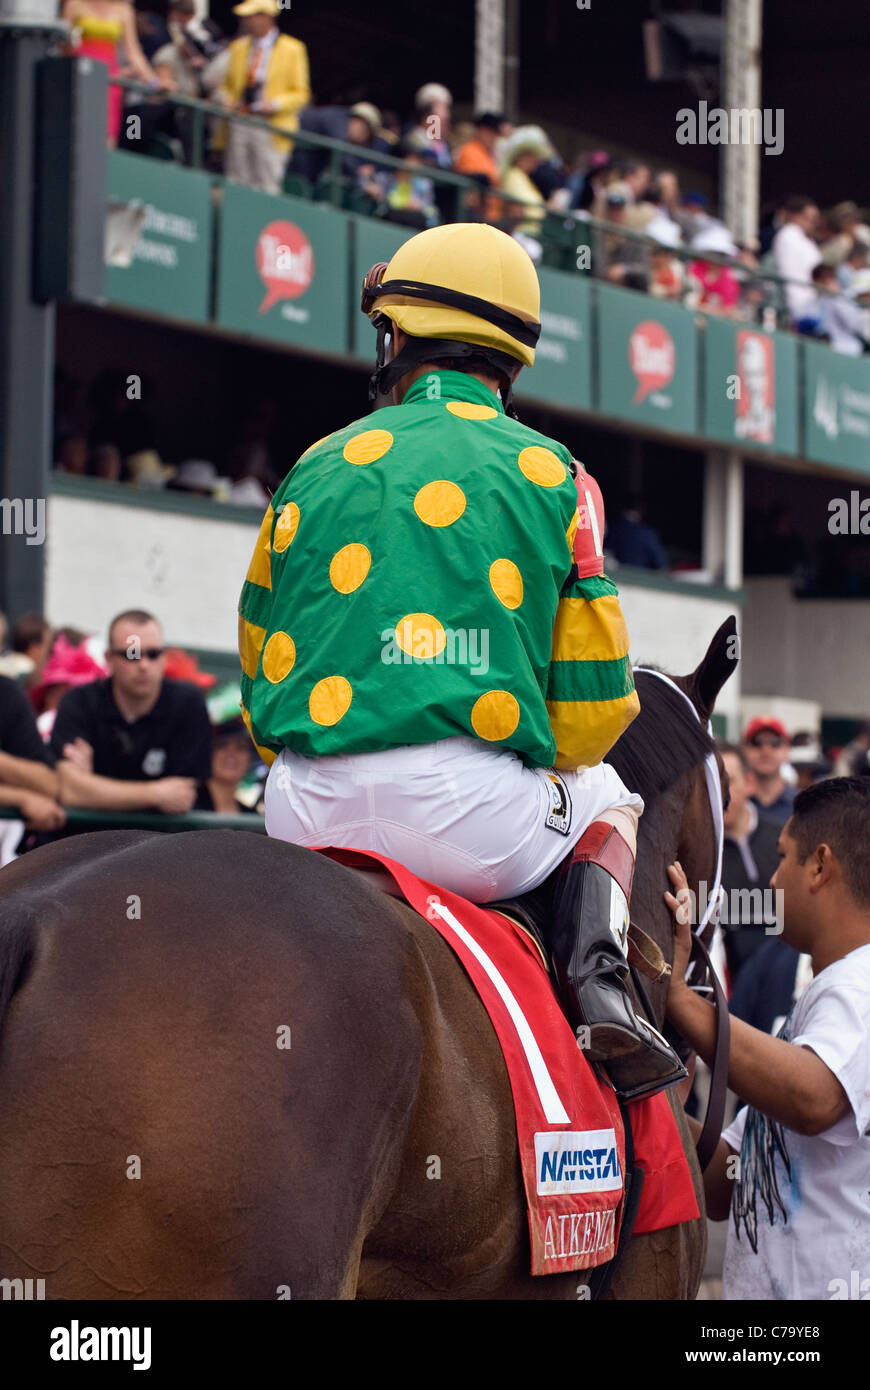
[703,318,798,453]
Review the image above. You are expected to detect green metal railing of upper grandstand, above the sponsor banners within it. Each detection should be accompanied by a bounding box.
[111,78,807,328]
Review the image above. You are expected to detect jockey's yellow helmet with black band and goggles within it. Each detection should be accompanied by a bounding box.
[363,222,541,367]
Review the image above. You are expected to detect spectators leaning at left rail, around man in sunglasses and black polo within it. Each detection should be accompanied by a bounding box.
[0,609,265,865]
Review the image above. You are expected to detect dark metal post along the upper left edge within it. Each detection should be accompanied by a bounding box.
[0,0,64,617]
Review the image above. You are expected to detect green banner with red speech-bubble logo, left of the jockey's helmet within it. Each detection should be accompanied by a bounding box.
[217,183,347,353]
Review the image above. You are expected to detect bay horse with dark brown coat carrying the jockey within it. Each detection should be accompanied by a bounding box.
[0,619,735,1300]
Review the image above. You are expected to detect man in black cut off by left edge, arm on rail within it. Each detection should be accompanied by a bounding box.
[0,676,65,838]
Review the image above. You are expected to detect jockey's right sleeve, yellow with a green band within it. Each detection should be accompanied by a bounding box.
[546,575,641,769]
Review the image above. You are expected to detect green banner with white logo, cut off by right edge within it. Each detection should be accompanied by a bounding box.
[802,343,870,473]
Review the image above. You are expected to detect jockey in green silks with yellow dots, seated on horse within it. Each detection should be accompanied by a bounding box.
[239,222,685,1099]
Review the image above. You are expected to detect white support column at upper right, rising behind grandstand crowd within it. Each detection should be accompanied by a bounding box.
[721,0,763,243]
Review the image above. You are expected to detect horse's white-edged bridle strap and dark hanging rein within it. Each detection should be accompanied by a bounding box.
[625,666,731,1172]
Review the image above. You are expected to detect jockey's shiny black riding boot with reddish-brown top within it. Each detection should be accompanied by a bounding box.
[550,821,687,1101]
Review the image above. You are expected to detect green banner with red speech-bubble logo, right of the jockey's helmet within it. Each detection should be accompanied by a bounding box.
[596,285,698,434]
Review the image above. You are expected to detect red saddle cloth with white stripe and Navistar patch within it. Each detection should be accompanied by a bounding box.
[320,847,699,1275]
